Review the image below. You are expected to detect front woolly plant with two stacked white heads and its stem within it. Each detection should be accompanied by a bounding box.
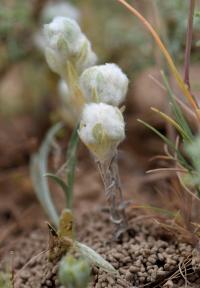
[79,64,128,237]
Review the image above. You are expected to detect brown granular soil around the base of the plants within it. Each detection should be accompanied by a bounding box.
[0,155,200,288]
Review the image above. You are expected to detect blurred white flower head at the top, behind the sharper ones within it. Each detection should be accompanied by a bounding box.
[41,1,80,23]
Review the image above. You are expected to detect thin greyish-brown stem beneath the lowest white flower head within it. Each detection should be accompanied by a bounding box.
[97,151,127,238]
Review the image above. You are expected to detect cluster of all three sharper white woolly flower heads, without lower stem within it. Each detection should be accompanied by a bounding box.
[44,17,128,161]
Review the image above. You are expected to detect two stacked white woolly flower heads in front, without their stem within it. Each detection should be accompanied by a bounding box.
[79,64,128,161]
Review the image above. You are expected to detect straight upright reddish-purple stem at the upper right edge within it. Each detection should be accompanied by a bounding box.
[184,0,195,89]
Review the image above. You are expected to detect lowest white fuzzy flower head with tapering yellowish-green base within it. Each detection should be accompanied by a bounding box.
[79,103,125,161]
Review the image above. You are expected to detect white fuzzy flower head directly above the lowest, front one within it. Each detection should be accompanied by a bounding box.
[80,64,128,106]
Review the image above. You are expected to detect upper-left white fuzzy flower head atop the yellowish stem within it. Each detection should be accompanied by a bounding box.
[44,17,96,78]
